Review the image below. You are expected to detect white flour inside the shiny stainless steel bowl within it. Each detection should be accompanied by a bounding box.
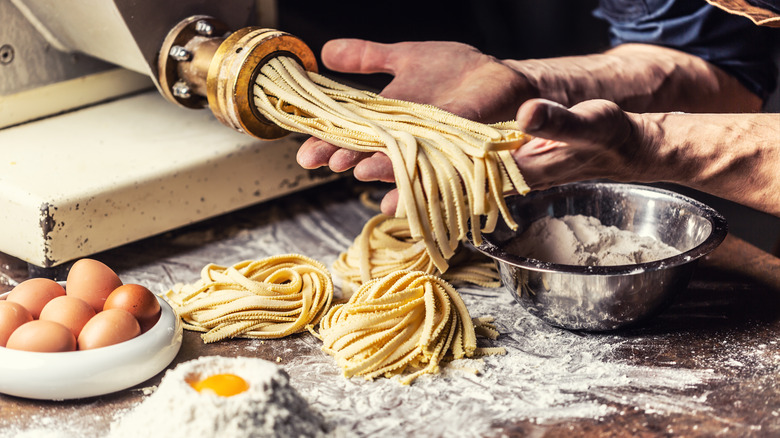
[512,215,680,266]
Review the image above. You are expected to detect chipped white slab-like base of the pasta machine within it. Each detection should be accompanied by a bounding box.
[0,91,335,267]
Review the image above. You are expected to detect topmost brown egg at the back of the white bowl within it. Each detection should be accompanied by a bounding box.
[65,259,122,313]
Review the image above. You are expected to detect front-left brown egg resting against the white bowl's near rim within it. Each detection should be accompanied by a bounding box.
[6,321,76,353]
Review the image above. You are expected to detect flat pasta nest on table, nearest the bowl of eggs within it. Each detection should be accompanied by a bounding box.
[164,254,333,343]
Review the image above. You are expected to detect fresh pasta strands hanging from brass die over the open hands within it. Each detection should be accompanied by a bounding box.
[254,56,529,272]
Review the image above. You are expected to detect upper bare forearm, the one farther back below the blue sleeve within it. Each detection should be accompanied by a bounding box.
[504,44,762,113]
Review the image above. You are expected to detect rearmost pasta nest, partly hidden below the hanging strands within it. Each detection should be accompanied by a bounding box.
[333,214,500,296]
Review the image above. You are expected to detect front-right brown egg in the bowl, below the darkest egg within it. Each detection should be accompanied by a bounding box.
[79,309,141,350]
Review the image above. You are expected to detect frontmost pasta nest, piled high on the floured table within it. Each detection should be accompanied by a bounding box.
[312,271,505,384]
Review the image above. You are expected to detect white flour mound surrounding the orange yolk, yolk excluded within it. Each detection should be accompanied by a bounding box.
[110,356,324,438]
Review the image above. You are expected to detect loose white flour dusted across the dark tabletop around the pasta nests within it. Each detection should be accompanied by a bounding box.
[120,202,720,437]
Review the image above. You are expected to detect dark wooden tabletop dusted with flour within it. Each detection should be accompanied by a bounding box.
[0,181,780,437]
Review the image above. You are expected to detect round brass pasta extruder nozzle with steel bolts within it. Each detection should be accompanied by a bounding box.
[157,15,317,139]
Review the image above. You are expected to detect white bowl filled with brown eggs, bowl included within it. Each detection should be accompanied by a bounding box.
[0,259,182,400]
